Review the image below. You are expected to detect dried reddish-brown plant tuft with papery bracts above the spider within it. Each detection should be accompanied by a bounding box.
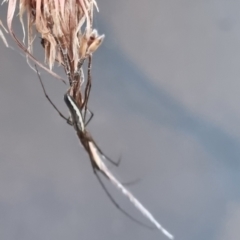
[6,0,104,82]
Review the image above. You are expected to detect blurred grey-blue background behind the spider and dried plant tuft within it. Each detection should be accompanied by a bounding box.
[0,0,240,240]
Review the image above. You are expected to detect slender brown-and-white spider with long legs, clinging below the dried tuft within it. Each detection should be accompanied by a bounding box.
[35,39,173,239]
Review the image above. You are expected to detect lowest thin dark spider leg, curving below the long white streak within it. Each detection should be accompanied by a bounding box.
[93,169,155,229]
